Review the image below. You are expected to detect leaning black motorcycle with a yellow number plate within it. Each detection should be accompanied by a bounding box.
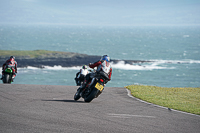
[74,71,109,102]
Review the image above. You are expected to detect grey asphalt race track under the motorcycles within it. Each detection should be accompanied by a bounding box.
[0,84,200,133]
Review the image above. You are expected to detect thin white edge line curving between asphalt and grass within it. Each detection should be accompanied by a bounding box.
[126,89,200,117]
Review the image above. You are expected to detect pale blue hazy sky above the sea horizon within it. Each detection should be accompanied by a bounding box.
[0,0,200,26]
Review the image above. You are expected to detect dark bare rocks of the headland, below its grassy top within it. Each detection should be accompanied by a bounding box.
[0,54,149,68]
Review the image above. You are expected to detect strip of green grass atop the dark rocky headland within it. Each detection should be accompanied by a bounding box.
[0,50,76,58]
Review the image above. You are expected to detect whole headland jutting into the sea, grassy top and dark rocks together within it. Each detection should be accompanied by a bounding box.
[0,50,152,68]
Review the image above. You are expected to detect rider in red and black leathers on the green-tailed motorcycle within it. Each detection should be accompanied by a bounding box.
[1,56,17,82]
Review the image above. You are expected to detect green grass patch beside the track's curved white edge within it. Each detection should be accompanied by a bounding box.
[126,85,200,115]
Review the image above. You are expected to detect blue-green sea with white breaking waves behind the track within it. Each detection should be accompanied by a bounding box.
[0,24,200,87]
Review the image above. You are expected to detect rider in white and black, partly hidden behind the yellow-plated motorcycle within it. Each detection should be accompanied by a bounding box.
[75,65,88,85]
